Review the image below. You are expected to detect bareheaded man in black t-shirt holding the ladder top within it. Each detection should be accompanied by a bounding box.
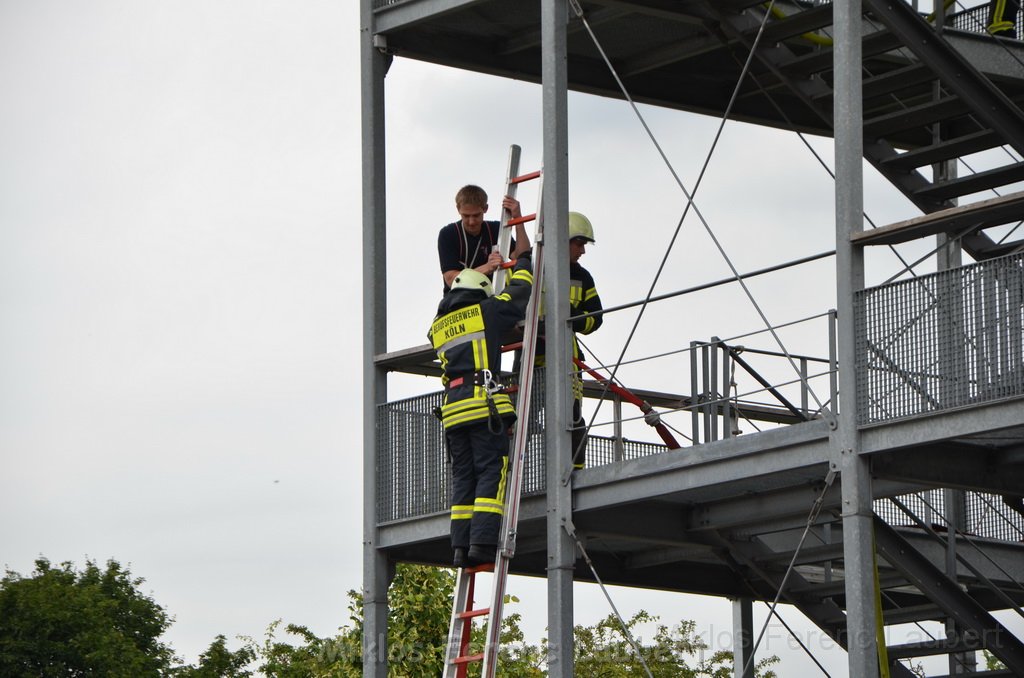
[437,184,529,292]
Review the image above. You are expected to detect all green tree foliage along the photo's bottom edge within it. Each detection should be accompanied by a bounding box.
[0,558,778,678]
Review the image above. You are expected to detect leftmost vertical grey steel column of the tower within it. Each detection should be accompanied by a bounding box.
[359,0,391,678]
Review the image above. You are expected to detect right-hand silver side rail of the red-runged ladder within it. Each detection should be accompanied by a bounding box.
[480,175,544,678]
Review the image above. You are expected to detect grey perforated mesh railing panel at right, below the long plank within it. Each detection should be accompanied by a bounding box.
[854,254,1024,424]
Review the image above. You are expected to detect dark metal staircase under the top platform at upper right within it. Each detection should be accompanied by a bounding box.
[710,0,1024,260]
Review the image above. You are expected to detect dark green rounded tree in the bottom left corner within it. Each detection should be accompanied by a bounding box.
[0,558,174,678]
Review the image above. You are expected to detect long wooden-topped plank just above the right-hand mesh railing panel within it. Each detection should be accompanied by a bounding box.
[850,192,1024,245]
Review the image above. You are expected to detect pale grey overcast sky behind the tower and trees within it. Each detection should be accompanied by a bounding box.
[0,0,1007,675]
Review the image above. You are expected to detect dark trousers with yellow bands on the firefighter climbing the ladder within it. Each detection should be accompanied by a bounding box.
[447,421,509,549]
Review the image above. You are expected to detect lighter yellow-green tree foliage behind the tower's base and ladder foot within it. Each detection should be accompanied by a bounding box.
[247,564,778,678]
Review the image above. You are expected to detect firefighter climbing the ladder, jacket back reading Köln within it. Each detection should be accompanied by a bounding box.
[427,252,534,567]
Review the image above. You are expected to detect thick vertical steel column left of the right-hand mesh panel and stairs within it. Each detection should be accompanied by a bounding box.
[831,0,879,678]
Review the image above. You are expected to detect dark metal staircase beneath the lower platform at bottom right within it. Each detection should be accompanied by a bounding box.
[714,503,1024,677]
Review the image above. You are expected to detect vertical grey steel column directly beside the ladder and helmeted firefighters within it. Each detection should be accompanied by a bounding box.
[541,0,575,678]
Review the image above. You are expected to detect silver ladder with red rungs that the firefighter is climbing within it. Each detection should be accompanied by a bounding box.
[442,145,544,678]
